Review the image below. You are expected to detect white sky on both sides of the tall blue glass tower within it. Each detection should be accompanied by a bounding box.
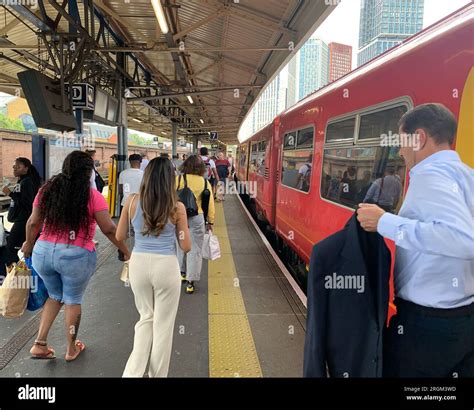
[312,0,471,68]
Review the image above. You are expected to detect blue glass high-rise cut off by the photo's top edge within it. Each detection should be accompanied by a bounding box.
[357,0,424,66]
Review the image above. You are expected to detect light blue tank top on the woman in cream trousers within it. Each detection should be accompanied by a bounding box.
[132,201,176,255]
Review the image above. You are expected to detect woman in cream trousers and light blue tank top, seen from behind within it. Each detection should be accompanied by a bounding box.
[117,158,191,377]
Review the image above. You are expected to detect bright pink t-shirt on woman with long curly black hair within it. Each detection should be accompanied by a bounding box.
[33,188,109,251]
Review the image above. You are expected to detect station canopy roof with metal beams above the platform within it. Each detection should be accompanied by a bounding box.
[0,0,334,144]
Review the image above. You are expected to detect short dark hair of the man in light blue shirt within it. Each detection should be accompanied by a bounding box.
[398,103,457,145]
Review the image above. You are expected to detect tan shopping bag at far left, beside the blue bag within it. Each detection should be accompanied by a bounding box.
[0,261,31,318]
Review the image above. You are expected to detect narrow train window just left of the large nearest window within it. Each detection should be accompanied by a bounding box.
[281,127,314,192]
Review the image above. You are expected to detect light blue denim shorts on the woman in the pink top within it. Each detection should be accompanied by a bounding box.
[32,241,97,305]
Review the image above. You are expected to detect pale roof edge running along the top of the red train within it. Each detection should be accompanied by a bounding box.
[284,3,474,117]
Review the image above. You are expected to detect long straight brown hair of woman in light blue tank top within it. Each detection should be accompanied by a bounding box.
[140,157,178,236]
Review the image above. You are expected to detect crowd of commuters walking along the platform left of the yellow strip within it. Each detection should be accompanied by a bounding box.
[0,144,230,377]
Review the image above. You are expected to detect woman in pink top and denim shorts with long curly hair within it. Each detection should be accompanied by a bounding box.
[22,151,130,361]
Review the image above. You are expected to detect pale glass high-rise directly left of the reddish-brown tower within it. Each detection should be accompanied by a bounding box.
[298,38,329,100]
